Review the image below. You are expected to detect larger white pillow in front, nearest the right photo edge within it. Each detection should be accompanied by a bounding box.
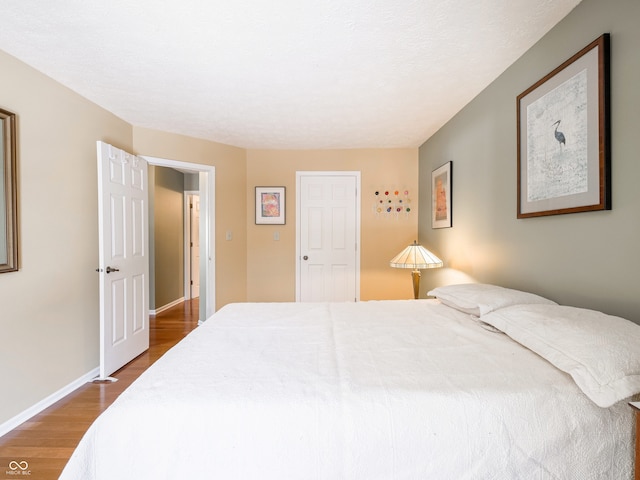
[482,305,640,407]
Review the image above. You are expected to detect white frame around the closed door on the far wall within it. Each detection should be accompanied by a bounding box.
[296,170,362,302]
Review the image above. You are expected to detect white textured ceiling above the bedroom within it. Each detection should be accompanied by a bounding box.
[0,0,580,149]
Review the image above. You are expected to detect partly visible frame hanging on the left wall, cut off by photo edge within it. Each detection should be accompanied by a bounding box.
[0,109,18,273]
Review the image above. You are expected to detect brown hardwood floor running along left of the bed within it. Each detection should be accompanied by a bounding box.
[0,299,198,480]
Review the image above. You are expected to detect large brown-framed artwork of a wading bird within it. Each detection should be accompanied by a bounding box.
[517,34,611,218]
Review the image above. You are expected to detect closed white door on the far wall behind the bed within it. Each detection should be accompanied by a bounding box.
[296,172,360,302]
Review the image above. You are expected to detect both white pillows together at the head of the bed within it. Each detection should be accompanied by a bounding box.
[428,284,640,407]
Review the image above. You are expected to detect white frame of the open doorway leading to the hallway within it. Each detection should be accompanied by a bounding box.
[139,155,216,324]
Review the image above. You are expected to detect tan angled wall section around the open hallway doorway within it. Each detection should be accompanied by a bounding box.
[133,127,247,309]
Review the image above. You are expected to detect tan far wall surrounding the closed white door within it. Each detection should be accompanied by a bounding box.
[246,148,418,301]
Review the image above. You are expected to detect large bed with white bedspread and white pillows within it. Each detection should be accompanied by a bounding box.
[61,285,640,480]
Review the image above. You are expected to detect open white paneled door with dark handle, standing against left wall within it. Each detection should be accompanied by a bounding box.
[97,142,149,379]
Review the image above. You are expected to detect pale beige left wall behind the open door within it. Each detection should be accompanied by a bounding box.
[0,51,133,425]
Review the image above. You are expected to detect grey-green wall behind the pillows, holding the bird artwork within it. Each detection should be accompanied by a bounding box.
[419,0,640,323]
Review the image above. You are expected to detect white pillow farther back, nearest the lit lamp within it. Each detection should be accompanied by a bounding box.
[427,283,557,317]
